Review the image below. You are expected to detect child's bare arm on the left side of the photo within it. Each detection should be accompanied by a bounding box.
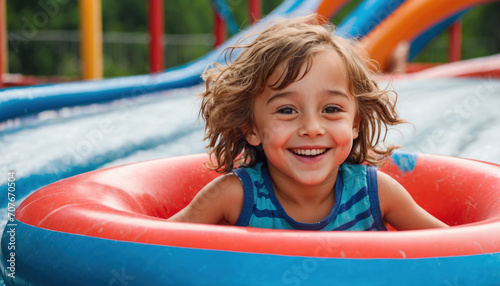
[168,174,244,225]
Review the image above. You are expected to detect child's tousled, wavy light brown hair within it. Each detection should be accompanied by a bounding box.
[200,14,405,173]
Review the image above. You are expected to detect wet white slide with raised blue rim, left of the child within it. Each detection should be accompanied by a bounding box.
[0,0,328,228]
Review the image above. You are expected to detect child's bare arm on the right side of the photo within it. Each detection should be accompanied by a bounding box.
[377,172,448,230]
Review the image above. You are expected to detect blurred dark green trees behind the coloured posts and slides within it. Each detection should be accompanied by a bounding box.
[7,0,500,79]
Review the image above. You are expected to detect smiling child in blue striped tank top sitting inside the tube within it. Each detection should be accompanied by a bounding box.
[170,15,447,230]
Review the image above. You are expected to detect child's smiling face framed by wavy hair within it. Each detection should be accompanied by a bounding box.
[246,48,359,185]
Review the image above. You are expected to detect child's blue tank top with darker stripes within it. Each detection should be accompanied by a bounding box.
[233,161,387,230]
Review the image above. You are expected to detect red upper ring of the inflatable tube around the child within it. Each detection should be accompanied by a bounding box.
[16,153,500,258]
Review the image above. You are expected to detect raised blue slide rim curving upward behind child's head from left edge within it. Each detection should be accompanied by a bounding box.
[0,0,321,122]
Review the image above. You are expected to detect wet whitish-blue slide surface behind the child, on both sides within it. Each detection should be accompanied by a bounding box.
[0,78,500,223]
